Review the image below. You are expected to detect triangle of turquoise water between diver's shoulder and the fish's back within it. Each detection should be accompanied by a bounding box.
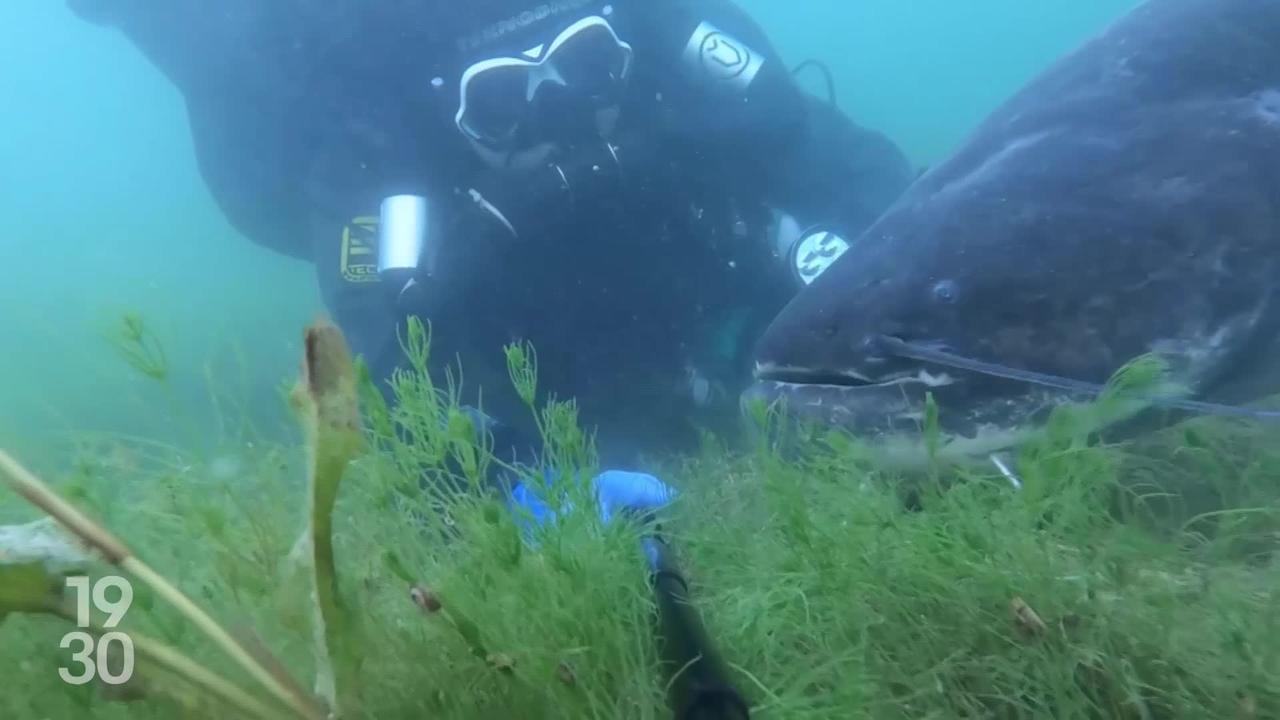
[740,0,1138,164]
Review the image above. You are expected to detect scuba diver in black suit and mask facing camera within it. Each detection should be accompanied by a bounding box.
[68,0,914,484]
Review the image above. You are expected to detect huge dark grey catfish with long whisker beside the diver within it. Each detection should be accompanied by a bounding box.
[745,0,1280,448]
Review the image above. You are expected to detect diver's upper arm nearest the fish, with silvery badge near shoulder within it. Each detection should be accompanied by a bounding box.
[641,0,914,271]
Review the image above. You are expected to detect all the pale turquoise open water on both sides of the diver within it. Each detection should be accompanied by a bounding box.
[0,0,1134,459]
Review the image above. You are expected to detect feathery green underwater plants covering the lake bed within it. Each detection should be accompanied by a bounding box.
[0,319,1280,720]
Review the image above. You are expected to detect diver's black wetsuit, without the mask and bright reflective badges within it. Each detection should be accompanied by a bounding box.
[69,0,913,464]
